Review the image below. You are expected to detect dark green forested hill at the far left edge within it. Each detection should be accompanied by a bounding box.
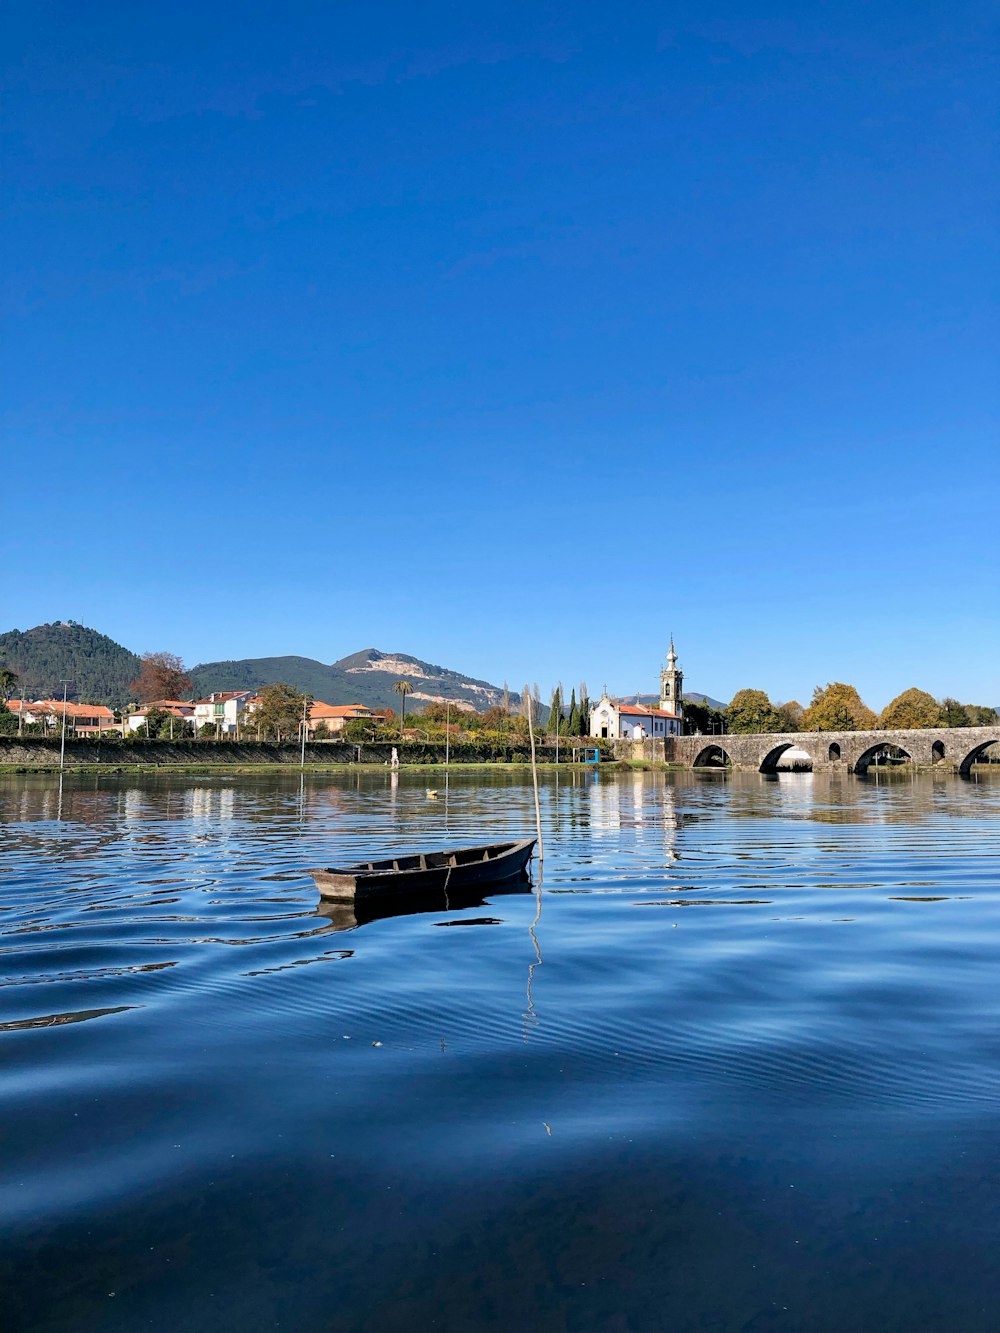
[0,620,139,708]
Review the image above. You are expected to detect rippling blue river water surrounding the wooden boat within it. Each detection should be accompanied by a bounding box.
[0,772,1000,1333]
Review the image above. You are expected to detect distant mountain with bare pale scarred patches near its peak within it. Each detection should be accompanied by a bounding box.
[191,648,520,712]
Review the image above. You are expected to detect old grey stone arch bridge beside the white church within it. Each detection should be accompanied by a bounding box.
[624,720,1000,773]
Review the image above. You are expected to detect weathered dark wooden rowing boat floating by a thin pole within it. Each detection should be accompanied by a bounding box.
[309,837,536,902]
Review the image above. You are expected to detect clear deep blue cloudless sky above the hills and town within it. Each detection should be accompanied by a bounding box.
[0,3,1000,706]
